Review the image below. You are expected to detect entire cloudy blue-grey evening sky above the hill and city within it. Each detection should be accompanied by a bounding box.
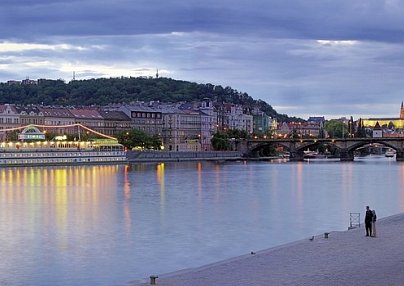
[0,0,404,120]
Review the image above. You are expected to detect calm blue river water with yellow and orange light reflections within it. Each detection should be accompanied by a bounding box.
[0,156,404,285]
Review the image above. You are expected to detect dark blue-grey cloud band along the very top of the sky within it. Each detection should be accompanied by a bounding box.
[0,0,404,41]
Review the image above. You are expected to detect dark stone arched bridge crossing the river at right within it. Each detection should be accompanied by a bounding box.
[234,137,404,161]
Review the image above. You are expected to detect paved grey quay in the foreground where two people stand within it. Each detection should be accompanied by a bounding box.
[125,213,404,286]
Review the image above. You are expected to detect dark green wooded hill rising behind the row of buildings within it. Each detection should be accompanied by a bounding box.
[0,77,299,121]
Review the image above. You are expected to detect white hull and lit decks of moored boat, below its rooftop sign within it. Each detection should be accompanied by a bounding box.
[0,140,127,167]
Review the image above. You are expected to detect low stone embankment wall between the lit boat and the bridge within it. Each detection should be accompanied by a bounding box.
[127,151,242,163]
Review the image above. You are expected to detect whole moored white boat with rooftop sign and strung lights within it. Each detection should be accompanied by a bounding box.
[0,124,127,167]
